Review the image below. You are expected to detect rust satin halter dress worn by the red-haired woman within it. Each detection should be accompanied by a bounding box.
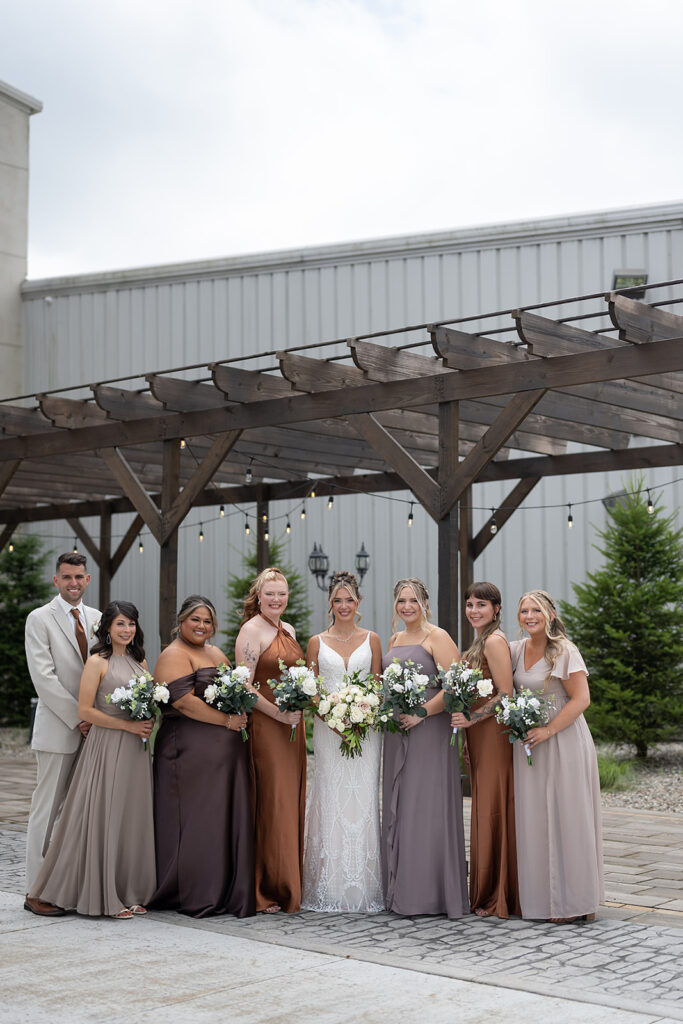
[245,612,306,913]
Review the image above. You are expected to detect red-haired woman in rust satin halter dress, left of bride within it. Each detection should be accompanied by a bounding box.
[234,568,306,913]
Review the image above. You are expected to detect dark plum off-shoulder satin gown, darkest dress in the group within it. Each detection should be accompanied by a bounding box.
[153,666,254,918]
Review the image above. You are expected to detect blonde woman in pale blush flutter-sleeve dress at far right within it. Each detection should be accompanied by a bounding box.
[510,590,604,925]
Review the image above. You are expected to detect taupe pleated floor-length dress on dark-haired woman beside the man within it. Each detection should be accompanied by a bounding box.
[31,654,156,918]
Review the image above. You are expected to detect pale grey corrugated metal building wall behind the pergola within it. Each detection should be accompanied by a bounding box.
[24,205,683,655]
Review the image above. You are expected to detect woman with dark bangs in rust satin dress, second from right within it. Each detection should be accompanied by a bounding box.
[451,583,521,918]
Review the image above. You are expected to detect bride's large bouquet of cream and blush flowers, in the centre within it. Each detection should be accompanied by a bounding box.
[317,669,382,758]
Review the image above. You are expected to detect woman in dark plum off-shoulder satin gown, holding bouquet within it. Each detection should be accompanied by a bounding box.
[153,594,254,918]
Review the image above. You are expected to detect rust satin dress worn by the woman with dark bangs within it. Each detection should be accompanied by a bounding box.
[467,657,521,918]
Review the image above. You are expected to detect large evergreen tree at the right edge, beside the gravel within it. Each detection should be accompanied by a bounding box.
[562,478,683,758]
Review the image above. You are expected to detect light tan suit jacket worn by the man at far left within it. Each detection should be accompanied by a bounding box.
[26,597,100,754]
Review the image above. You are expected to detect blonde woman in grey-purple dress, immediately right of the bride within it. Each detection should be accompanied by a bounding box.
[382,579,469,918]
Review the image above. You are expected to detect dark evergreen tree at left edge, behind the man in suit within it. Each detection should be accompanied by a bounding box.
[0,534,52,726]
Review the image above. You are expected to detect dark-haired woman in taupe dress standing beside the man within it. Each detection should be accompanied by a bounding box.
[31,601,155,919]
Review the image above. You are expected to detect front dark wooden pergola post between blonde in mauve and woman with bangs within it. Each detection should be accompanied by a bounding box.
[438,401,459,640]
